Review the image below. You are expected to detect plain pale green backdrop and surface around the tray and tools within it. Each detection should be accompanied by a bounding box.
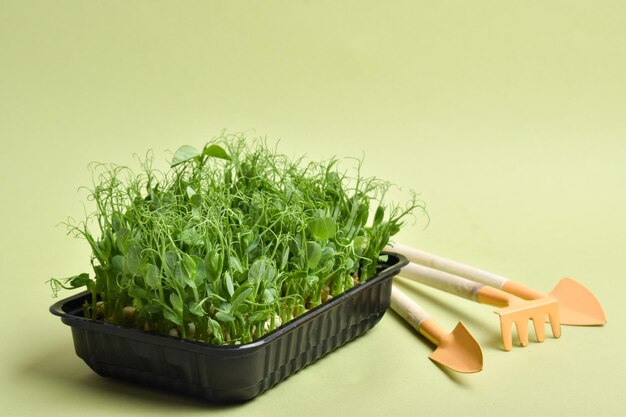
[0,0,626,416]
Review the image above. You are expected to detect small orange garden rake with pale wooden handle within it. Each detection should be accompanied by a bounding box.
[399,263,561,351]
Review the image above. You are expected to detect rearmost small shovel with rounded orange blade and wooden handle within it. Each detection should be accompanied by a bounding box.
[390,243,606,326]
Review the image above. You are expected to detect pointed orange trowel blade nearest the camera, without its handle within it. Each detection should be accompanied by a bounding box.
[428,322,483,373]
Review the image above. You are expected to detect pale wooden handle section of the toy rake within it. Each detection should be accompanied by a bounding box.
[399,263,484,301]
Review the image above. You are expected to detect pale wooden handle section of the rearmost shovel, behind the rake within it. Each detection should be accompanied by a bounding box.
[387,243,508,288]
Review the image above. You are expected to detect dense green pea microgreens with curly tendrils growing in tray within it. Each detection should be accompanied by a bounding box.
[49,135,423,344]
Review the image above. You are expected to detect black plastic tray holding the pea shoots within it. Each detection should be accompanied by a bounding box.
[50,254,408,402]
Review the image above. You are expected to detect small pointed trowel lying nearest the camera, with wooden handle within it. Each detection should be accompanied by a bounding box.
[391,285,483,373]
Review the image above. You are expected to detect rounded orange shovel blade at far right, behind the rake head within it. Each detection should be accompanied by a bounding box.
[550,278,606,326]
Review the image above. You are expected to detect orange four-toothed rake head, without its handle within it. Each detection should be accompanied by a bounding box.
[494,297,561,351]
